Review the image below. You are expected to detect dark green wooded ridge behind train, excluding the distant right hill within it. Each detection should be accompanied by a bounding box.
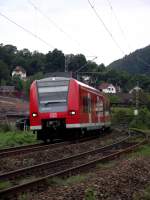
[0,44,103,84]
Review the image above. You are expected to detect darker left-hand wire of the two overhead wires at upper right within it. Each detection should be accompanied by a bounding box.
[88,0,126,56]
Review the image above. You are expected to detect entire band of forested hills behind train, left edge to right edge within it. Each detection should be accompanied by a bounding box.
[0,44,150,96]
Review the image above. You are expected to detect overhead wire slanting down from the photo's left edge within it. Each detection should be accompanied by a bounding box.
[0,12,54,48]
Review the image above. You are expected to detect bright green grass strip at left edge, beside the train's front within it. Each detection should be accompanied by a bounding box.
[0,131,37,149]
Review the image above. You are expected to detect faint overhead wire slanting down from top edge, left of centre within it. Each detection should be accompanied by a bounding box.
[28,0,95,57]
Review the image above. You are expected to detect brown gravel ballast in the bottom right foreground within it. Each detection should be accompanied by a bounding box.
[34,158,150,200]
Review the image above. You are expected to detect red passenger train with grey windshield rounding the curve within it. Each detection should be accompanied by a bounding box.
[30,77,111,141]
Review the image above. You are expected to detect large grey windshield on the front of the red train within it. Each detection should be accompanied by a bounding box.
[37,81,69,112]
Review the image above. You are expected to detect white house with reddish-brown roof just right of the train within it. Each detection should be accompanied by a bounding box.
[99,83,117,94]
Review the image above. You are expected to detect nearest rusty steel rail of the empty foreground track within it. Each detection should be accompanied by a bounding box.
[0,136,147,199]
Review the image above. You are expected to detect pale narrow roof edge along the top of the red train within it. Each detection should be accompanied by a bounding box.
[37,77,100,93]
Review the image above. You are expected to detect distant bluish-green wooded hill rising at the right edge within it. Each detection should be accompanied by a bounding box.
[108,46,150,74]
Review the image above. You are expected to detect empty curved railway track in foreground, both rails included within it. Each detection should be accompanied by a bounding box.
[0,136,147,199]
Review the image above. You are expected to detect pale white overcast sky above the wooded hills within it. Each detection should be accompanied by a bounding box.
[0,0,150,65]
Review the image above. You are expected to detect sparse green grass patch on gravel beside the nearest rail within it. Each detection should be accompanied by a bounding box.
[48,175,87,186]
